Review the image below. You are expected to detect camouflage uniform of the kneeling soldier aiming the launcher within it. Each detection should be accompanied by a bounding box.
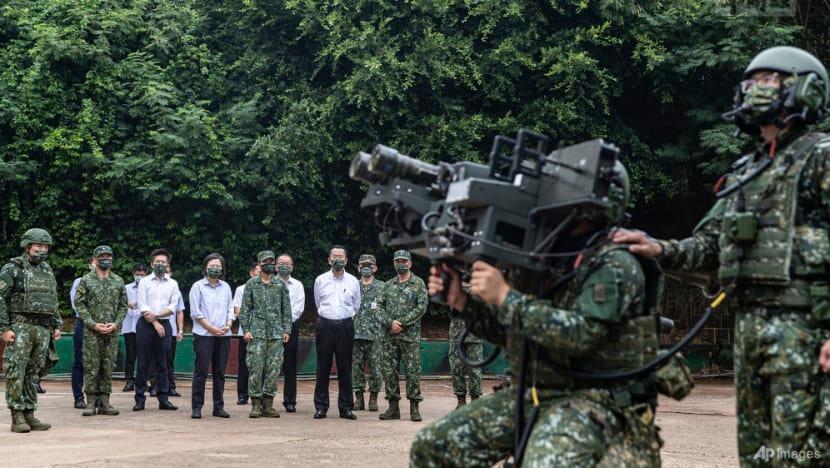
[410,247,660,467]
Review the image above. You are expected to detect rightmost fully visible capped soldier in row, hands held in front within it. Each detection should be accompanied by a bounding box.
[380,250,429,421]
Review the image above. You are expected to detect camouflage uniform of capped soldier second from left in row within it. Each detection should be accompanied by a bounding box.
[75,271,127,401]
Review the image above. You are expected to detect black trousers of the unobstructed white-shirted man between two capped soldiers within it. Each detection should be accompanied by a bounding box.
[314,317,354,411]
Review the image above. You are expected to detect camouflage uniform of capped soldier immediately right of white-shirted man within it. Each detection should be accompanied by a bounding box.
[352,279,386,393]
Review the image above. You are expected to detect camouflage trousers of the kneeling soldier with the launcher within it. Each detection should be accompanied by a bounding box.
[409,390,660,468]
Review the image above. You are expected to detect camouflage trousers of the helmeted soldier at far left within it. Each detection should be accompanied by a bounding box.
[3,322,51,410]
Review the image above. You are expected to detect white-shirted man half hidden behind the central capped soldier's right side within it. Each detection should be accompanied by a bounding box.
[277,253,305,413]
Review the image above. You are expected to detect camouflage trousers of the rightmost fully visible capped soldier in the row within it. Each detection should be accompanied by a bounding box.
[380,339,424,401]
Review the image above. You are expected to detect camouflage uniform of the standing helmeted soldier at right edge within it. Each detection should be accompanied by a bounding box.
[658,129,830,466]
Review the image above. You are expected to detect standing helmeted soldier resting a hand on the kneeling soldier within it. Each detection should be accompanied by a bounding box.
[614,47,830,466]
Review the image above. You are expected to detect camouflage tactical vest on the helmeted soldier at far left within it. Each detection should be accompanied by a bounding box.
[9,258,58,315]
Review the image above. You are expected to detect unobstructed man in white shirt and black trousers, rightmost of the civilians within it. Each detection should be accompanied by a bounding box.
[314,245,360,419]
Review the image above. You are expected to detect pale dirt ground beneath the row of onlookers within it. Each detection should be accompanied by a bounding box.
[0,379,737,467]
